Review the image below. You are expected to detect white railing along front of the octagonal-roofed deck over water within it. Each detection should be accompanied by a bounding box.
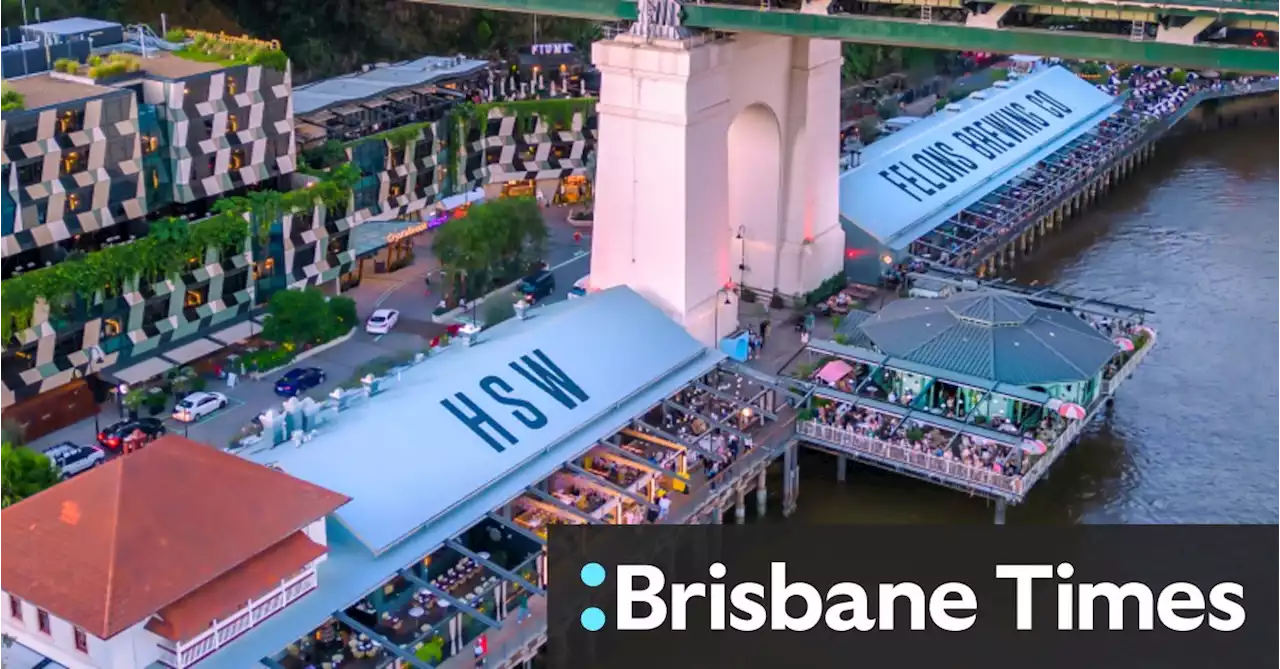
[796,421,1029,501]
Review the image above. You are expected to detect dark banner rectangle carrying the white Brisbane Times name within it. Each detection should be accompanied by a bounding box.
[548,526,1280,669]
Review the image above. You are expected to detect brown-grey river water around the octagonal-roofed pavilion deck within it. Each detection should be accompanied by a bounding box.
[794,127,1280,524]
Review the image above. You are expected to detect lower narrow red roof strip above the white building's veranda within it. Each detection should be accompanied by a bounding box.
[147,532,325,641]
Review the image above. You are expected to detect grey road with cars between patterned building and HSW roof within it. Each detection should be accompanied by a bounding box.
[28,209,590,452]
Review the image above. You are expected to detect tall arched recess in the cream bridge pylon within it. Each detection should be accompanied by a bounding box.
[726,102,785,290]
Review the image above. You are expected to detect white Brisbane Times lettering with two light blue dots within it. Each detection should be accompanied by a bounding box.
[579,562,1247,632]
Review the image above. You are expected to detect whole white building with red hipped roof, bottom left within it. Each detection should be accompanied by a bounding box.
[0,436,349,669]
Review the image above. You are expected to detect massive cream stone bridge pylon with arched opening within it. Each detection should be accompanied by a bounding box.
[591,24,845,343]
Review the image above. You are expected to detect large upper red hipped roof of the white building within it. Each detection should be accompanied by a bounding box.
[0,436,349,638]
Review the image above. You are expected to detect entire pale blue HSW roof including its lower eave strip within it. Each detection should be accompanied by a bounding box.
[201,287,724,669]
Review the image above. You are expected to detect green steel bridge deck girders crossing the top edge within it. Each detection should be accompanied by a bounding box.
[417,0,1280,74]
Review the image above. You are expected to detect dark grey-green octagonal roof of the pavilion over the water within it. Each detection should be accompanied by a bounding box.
[840,290,1117,388]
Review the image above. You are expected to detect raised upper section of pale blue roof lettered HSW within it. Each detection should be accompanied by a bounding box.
[240,288,718,553]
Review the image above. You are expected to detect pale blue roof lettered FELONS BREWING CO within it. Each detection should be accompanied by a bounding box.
[840,67,1117,249]
